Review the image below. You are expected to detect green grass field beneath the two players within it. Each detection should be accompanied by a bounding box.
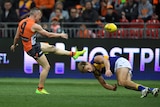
[0,78,160,107]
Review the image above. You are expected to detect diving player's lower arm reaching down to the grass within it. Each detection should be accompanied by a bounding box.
[96,76,117,91]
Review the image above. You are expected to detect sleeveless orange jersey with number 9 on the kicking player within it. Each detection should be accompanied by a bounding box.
[18,18,37,52]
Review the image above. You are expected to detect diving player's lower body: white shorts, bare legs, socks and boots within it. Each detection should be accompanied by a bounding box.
[115,58,159,98]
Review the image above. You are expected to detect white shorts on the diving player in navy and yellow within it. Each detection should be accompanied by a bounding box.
[114,57,132,75]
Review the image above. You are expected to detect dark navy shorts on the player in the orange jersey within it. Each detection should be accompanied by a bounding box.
[27,42,43,60]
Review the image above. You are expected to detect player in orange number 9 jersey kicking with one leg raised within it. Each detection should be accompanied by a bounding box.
[10,8,85,94]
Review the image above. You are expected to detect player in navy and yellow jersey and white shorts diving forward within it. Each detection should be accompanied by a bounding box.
[78,55,159,98]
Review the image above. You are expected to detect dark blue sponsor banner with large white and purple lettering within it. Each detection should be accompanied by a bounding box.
[0,38,160,80]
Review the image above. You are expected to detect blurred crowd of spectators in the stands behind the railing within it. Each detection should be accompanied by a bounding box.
[0,0,160,37]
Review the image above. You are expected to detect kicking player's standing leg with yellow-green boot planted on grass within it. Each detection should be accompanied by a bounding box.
[36,54,50,94]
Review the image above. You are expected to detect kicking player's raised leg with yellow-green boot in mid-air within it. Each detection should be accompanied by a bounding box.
[40,42,86,59]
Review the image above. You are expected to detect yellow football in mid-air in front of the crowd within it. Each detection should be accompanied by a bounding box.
[104,23,117,33]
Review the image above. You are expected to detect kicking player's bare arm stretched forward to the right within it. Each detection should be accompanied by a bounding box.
[31,24,68,39]
